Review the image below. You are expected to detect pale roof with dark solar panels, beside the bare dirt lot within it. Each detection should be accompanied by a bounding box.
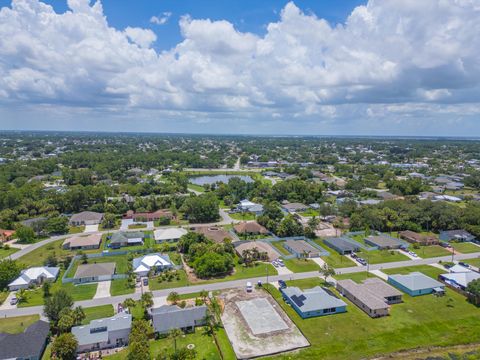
[282,286,347,312]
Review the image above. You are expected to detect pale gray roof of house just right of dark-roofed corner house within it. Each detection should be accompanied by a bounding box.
[72,313,132,345]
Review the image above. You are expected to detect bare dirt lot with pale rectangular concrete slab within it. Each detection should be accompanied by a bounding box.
[220,289,310,359]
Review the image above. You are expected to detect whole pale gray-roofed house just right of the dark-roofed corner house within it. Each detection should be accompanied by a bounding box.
[72,312,132,353]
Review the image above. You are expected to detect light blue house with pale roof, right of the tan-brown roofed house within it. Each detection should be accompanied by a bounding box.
[388,271,445,296]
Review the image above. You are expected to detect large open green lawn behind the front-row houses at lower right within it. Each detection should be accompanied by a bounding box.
[266,276,480,360]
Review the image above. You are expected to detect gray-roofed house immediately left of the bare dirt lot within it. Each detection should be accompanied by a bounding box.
[151,305,207,335]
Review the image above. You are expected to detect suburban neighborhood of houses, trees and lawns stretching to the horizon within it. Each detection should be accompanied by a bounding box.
[0,133,480,359]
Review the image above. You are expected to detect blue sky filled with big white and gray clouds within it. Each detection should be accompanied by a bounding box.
[0,0,480,135]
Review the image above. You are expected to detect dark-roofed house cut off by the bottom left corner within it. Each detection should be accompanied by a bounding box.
[0,320,50,360]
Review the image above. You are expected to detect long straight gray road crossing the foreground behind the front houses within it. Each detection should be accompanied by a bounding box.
[0,252,480,318]
